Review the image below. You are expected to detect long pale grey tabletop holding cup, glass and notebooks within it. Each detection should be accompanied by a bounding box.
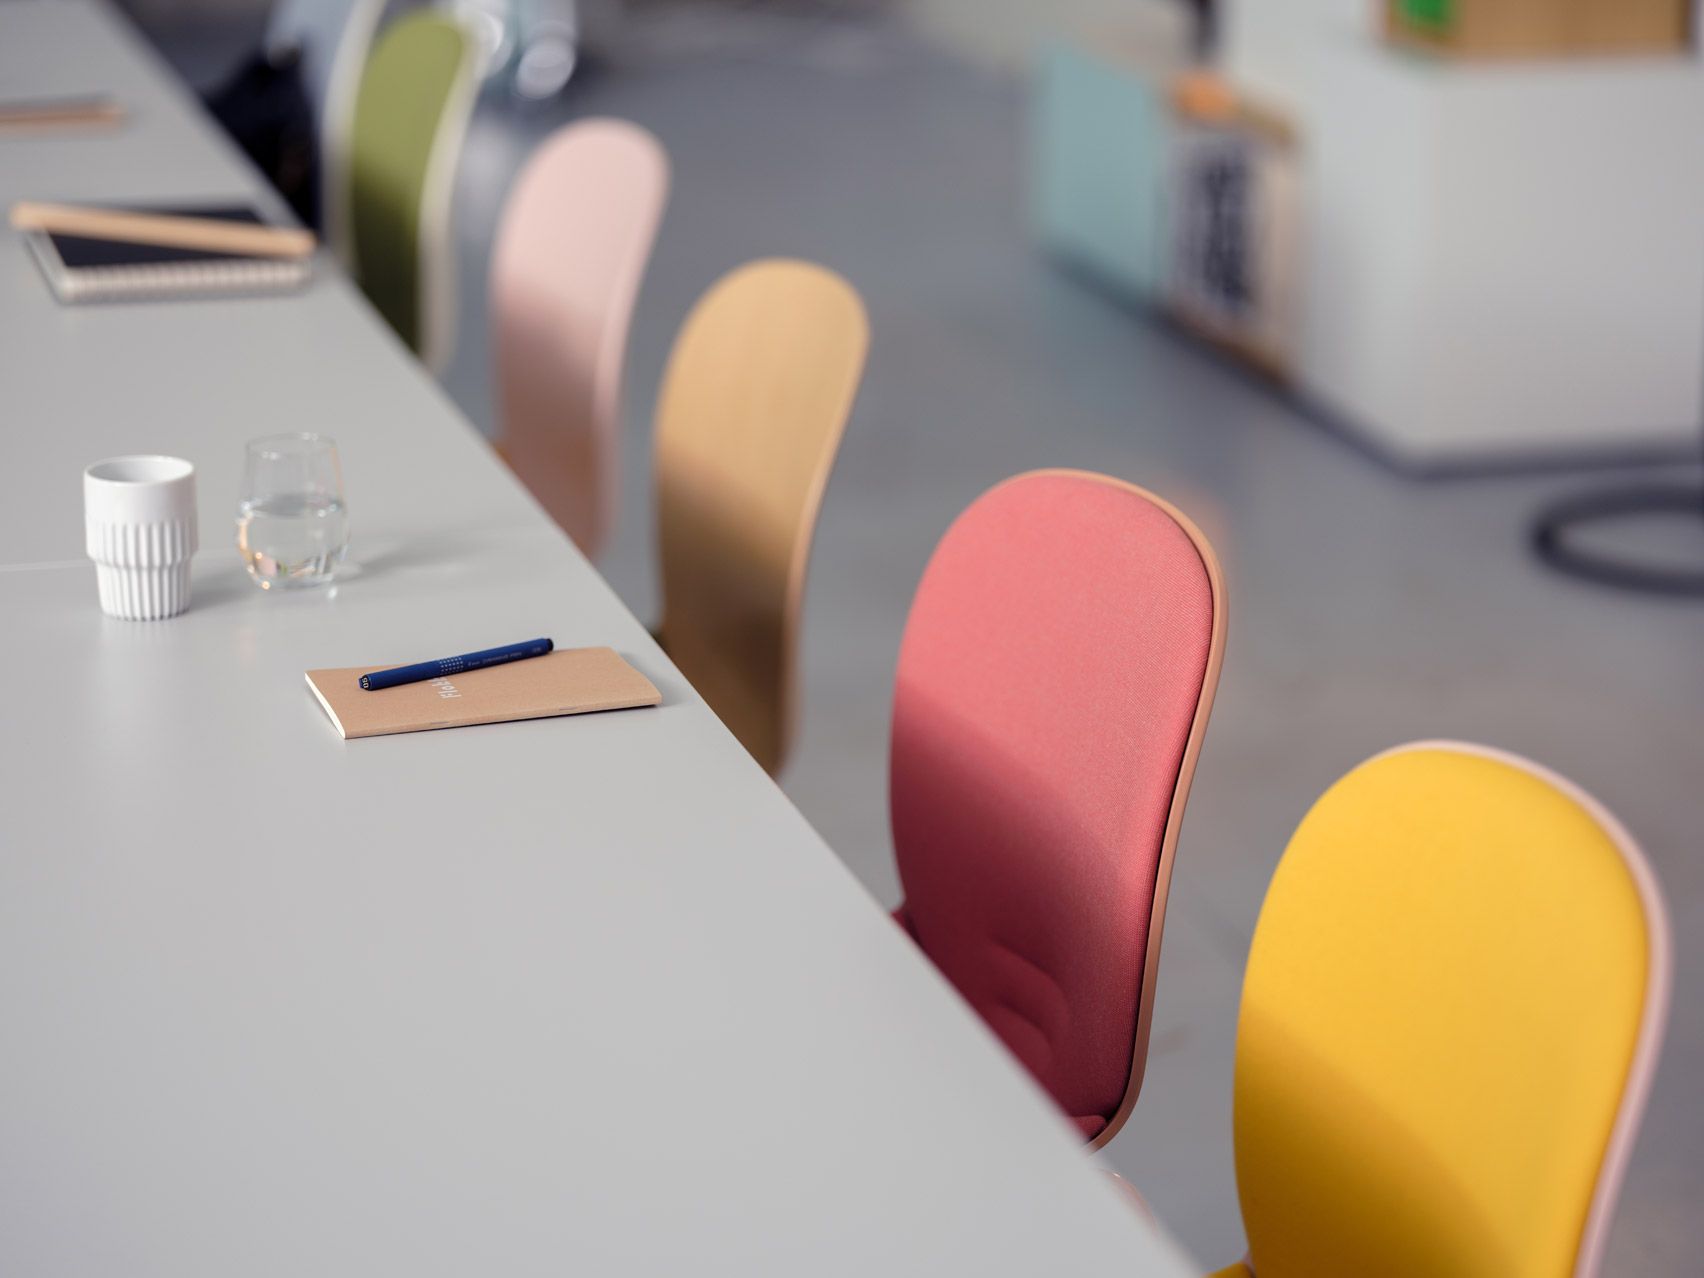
[0,0,1195,1278]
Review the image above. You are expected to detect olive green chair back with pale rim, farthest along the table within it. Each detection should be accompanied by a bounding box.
[348,10,475,371]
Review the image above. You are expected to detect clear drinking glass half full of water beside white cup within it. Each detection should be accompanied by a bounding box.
[237,435,349,590]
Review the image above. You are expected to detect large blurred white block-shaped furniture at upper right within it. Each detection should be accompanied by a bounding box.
[1222,0,1704,469]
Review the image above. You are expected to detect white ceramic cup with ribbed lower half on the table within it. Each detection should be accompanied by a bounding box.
[83,455,198,622]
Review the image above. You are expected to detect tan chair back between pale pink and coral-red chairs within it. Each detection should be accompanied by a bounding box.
[656,259,869,774]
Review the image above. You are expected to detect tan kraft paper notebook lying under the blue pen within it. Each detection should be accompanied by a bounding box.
[308,648,663,741]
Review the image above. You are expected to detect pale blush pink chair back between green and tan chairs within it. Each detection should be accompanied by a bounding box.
[491,119,668,556]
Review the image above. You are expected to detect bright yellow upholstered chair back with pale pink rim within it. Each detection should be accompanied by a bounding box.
[1235,743,1668,1278]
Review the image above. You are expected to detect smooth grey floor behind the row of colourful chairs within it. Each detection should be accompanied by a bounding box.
[160,12,1704,1275]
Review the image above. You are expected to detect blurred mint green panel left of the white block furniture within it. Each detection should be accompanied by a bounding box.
[1029,43,1171,302]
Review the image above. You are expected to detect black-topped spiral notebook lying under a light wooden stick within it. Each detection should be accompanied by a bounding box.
[26,204,312,302]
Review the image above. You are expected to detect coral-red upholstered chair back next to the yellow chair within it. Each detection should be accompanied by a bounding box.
[889,470,1225,1145]
